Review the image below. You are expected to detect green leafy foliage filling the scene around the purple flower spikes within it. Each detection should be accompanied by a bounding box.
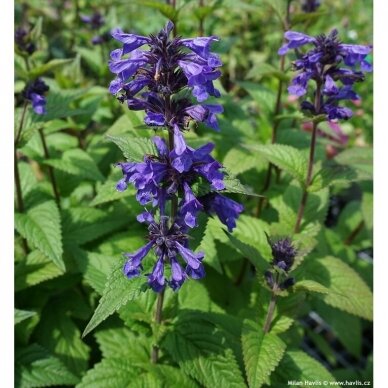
[15,0,373,388]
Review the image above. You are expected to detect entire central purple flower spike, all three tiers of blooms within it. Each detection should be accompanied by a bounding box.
[109,22,243,292]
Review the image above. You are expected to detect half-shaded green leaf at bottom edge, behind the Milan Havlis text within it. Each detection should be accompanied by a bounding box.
[270,350,335,387]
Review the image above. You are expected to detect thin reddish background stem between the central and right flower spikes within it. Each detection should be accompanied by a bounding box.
[255,0,292,217]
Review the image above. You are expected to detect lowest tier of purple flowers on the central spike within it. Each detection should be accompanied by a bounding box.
[123,212,205,292]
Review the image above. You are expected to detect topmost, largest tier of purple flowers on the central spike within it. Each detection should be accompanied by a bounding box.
[109,22,223,149]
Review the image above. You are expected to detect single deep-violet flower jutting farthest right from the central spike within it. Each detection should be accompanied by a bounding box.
[199,193,244,232]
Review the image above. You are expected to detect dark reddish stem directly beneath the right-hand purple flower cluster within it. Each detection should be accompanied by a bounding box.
[294,82,321,233]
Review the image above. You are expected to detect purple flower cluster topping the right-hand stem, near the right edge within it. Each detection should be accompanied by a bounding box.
[279,30,372,120]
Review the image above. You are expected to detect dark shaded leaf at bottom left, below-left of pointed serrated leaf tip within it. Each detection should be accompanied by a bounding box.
[35,304,90,376]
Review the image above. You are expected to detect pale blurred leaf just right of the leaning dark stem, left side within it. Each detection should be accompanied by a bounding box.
[44,148,105,181]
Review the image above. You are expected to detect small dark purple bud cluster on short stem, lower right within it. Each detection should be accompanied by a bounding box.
[264,238,297,290]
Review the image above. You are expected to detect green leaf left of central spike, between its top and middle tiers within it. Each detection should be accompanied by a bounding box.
[107,136,158,163]
